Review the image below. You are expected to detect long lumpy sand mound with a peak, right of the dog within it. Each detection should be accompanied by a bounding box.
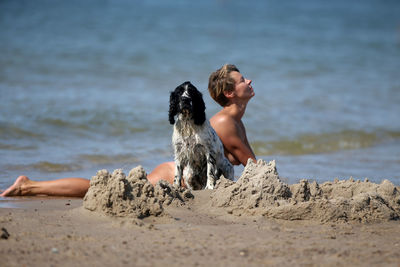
[211,160,400,222]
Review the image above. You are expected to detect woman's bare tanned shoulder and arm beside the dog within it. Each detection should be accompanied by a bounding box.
[214,117,256,166]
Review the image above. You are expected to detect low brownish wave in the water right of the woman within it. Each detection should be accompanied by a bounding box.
[251,130,400,156]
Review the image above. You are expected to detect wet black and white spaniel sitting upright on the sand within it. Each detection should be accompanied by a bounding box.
[169,82,233,190]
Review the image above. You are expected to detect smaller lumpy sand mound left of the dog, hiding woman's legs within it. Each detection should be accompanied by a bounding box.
[83,166,193,218]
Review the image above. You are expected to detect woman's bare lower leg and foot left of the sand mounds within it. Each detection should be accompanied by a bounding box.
[1,176,90,197]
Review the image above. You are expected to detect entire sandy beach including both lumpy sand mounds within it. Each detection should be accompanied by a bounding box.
[0,161,400,266]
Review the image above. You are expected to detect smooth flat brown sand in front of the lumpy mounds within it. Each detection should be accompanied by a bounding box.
[0,195,400,266]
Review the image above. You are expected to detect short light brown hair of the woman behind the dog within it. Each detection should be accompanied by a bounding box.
[208,64,240,107]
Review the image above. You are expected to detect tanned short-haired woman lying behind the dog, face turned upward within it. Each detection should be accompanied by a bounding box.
[1,64,256,197]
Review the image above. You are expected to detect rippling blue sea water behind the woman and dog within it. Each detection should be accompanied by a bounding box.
[0,0,400,188]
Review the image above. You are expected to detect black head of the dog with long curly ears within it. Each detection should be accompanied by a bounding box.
[169,82,206,125]
